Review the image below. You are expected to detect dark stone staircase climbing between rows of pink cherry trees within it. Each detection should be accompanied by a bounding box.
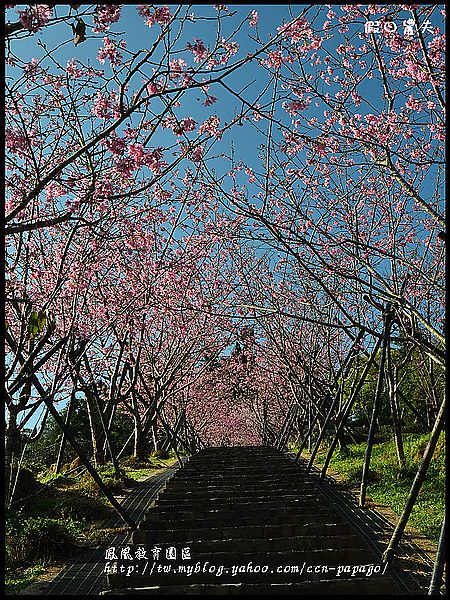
[102,446,401,595]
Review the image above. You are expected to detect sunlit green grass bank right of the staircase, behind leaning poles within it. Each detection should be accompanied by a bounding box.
[292,434,445,542]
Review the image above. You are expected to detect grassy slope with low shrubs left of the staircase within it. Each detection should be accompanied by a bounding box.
[5,456,180,595]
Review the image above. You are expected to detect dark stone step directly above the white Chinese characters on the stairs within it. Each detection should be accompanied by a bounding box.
[131,522,354,544]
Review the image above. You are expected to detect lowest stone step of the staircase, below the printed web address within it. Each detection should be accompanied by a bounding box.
[100,576,400,597]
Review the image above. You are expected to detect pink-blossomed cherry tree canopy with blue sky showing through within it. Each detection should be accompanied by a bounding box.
[5,4,445,464]
